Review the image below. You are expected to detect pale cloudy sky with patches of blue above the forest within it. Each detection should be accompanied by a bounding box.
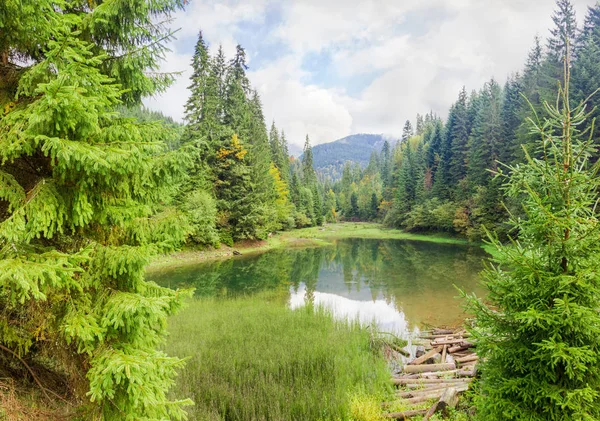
[146,0,596,150]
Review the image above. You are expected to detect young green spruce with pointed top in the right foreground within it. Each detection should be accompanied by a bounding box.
[469,40,600,421]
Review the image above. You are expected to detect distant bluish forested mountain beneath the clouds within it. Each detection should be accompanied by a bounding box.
[313,133,391,181]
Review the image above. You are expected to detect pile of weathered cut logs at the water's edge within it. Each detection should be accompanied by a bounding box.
[384,329,479,420]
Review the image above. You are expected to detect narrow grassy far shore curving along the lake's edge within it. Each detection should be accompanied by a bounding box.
[146,222,471,272]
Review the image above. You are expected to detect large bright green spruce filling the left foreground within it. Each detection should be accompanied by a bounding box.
[0,0,189,420]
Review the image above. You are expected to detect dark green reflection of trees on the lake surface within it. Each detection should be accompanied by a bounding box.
[151,239,484,316]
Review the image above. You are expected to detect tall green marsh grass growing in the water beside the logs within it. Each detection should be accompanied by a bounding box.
[166,291,390,421]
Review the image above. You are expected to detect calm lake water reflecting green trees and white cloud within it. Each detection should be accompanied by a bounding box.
[148,239,486,336]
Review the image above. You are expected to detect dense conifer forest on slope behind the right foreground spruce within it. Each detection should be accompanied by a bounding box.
[327,0,600,239]
